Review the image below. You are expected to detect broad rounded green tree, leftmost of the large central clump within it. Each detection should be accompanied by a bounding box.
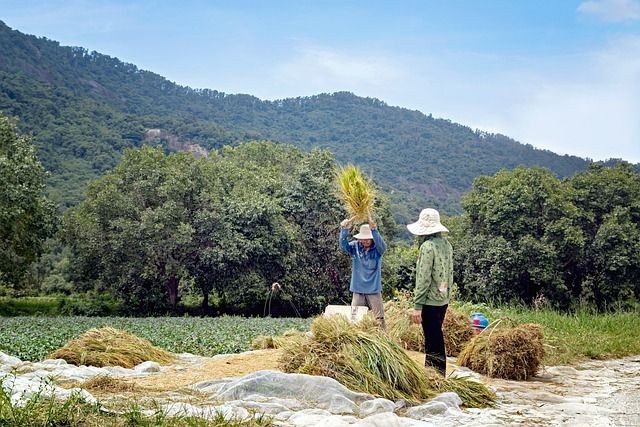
[64,147,202,312]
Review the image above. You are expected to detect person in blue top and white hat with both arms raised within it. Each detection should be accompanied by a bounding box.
[340,217,387,329]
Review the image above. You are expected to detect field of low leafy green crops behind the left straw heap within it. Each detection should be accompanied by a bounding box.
[0,316,311,361]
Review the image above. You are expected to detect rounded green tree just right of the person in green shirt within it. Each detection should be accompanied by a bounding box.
[455,167,584,307]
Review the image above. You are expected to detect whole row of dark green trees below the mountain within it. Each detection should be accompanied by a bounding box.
[0,113,640,316]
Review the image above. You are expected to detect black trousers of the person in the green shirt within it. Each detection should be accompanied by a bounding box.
[422,304,448,376]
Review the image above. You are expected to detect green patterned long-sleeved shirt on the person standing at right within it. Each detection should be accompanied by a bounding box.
[413,233,453,310]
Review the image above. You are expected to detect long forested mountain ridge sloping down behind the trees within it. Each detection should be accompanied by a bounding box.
[0,21,588,221]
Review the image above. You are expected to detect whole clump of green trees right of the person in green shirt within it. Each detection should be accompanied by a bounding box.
[452,163,640,308]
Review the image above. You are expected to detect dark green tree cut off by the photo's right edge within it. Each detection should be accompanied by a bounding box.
[566,162,640,309]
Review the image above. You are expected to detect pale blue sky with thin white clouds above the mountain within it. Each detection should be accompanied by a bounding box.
[0,0,640,162]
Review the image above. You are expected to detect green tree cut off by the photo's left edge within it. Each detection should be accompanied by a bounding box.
[0,115,58,287]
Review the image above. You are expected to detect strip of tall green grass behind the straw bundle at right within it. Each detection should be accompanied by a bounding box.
[459,304,640,366]
